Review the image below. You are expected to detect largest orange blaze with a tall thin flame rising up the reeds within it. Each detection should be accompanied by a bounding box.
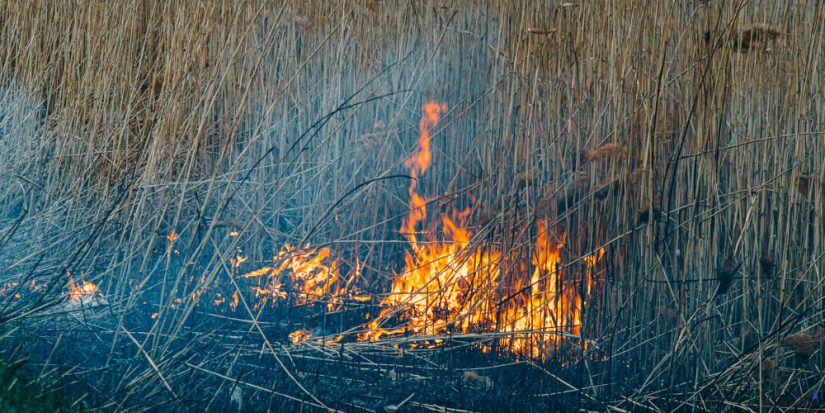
[359,103,604,357]
